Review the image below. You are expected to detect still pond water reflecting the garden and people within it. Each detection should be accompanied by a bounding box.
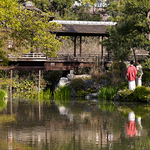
[0,95,150,150]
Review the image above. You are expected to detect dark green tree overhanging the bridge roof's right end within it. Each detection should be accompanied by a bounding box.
[104,0,150,80]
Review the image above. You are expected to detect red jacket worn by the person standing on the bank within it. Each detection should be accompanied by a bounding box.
[126,65,137,81]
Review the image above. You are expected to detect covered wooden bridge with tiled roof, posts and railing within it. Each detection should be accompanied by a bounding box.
[0,20,115,70]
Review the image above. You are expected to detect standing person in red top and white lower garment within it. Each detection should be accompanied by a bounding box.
[126,61,137,90]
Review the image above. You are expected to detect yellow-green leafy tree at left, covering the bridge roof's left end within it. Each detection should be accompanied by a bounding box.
[0,0,60,63]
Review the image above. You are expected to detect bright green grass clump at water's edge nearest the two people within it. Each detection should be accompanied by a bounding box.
[98,86,119,100]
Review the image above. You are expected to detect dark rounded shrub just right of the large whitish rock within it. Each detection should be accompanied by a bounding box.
[70,78,85,92]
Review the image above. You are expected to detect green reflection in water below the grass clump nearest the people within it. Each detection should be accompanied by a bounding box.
[99,100,118,112]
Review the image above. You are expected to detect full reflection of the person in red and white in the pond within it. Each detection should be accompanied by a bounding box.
[127,112,136,137]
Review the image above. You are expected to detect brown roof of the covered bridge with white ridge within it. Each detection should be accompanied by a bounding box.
[52,20,116,36]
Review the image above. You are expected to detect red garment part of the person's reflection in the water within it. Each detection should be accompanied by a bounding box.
[127,121,136,137]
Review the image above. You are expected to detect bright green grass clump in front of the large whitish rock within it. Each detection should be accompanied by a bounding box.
[54,86,71,100]
